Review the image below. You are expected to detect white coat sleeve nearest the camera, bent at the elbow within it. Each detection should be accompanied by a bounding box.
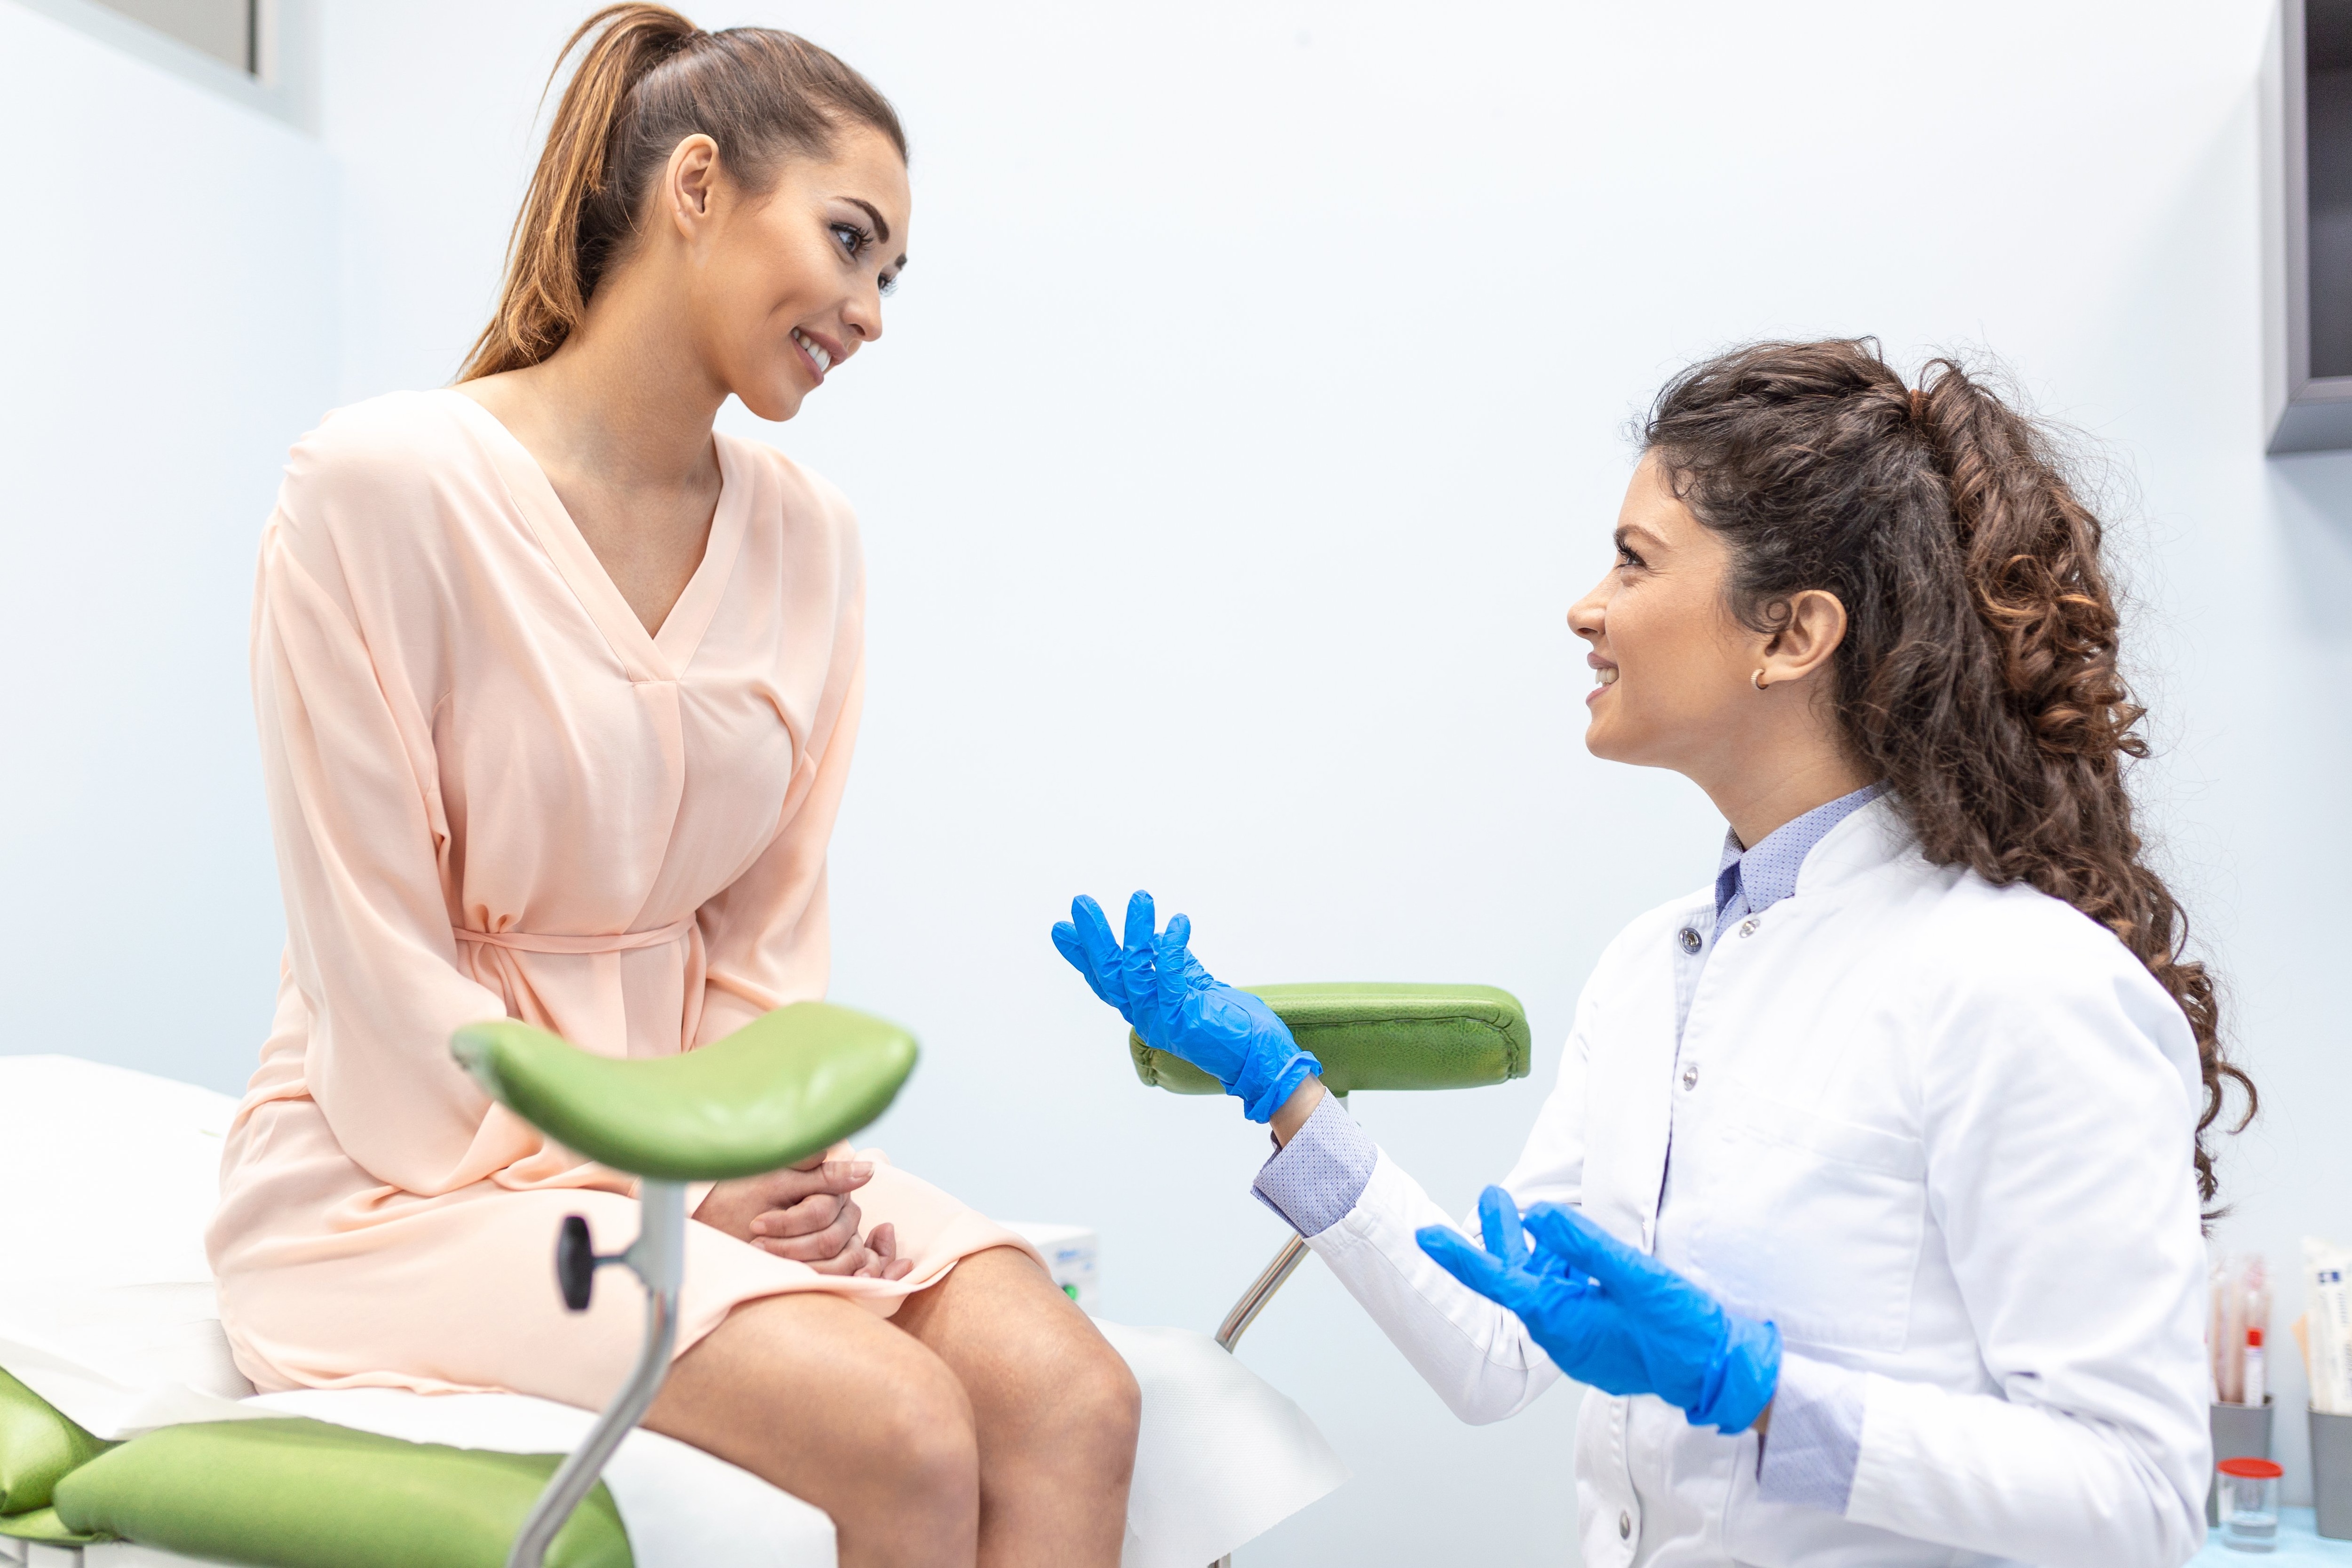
[1825,955,2211,1563]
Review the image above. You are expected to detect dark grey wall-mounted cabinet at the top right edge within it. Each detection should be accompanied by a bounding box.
[2267,0,2352,454]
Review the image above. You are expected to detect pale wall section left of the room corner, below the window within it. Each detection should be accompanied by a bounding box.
[0,2,334,1089]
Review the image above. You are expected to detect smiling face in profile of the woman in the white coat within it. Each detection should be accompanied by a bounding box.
[1569,454,1757,780]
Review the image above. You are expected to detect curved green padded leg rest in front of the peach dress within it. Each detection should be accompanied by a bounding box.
[449,1002,915,1182]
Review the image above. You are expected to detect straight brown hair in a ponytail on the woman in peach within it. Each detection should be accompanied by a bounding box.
[459,5,906,381]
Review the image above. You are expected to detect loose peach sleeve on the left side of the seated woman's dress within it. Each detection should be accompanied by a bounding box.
[254,510,520,1194]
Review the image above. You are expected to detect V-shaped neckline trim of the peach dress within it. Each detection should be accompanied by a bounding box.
[440,388,750,682]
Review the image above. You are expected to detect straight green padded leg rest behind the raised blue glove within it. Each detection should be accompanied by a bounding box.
[1127,983,1529,1096]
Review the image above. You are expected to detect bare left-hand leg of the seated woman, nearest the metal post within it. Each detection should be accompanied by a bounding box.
[644,1269,978,1568]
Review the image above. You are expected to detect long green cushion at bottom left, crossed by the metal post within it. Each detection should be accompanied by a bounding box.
[56,1417,635,1568]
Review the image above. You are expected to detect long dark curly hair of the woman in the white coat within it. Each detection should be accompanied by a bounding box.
[1642,339,2258,1218]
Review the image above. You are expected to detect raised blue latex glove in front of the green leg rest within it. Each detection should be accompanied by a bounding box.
[1054,893,1322,1122]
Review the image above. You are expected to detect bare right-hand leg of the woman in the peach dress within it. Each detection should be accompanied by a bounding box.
[891,1248,1143,1568]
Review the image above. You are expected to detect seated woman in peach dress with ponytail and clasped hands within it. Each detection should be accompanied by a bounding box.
[212,5,1138,1568]
